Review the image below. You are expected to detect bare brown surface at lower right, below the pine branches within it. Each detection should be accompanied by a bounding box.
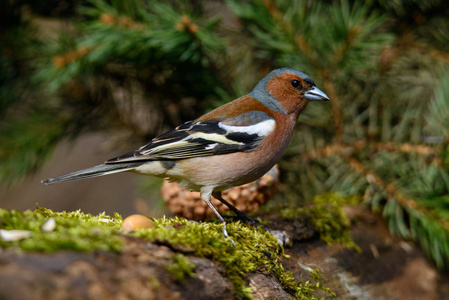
[276,207,449,300]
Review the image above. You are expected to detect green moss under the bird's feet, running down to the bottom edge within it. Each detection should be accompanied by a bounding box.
[132,218,333,299]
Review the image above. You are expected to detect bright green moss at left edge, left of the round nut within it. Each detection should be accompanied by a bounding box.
[0,206,123,252]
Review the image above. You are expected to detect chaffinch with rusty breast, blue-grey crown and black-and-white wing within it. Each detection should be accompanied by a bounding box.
[42,67,330,241]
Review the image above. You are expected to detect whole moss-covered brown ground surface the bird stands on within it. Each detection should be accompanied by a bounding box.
[0,199,449,300]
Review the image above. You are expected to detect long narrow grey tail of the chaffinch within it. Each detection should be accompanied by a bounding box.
[41,162,142,184]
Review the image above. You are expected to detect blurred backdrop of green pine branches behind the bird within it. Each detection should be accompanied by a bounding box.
[0,0,449,267]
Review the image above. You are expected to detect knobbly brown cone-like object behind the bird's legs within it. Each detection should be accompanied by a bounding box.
[161,165,279,219]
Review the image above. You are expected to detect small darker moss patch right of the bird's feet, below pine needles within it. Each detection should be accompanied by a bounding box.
[281,193,361,252]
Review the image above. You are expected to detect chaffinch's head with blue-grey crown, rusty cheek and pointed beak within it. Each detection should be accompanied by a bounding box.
[249,68,330,114]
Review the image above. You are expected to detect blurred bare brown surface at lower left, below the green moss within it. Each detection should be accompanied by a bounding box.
[0,238,234,299]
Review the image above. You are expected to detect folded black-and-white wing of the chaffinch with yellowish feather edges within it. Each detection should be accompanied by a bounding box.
[106,111,275,163]
